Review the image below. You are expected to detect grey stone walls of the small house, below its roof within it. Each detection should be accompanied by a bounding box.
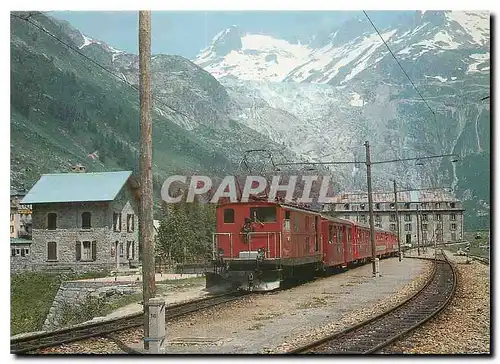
[31,186,139,272]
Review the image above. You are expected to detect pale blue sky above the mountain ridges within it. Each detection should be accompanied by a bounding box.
[49,11,412,59]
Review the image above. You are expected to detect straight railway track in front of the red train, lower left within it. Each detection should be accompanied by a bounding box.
[10,293,244,354]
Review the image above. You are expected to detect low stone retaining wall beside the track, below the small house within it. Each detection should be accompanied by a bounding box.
[42,281,142,331]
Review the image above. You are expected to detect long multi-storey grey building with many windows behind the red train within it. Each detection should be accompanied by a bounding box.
[325,190,465,245]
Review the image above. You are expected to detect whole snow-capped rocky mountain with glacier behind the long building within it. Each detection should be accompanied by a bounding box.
[194,11,490,228]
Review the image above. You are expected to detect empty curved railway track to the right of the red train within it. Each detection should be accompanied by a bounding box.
[289,254,457,355]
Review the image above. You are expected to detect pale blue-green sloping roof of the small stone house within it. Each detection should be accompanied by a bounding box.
[21,171,132,204]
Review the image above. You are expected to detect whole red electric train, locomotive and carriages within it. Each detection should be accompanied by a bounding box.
[206,201,397,291]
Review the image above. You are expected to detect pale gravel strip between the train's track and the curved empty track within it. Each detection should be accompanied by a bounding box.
[122,258,431,354]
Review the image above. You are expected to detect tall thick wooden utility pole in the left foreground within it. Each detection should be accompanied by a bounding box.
[139,11,155,350]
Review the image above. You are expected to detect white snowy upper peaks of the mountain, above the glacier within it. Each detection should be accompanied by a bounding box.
[194,12,489,85]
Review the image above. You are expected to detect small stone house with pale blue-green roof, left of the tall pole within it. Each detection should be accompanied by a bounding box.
[22,171,140,271]
